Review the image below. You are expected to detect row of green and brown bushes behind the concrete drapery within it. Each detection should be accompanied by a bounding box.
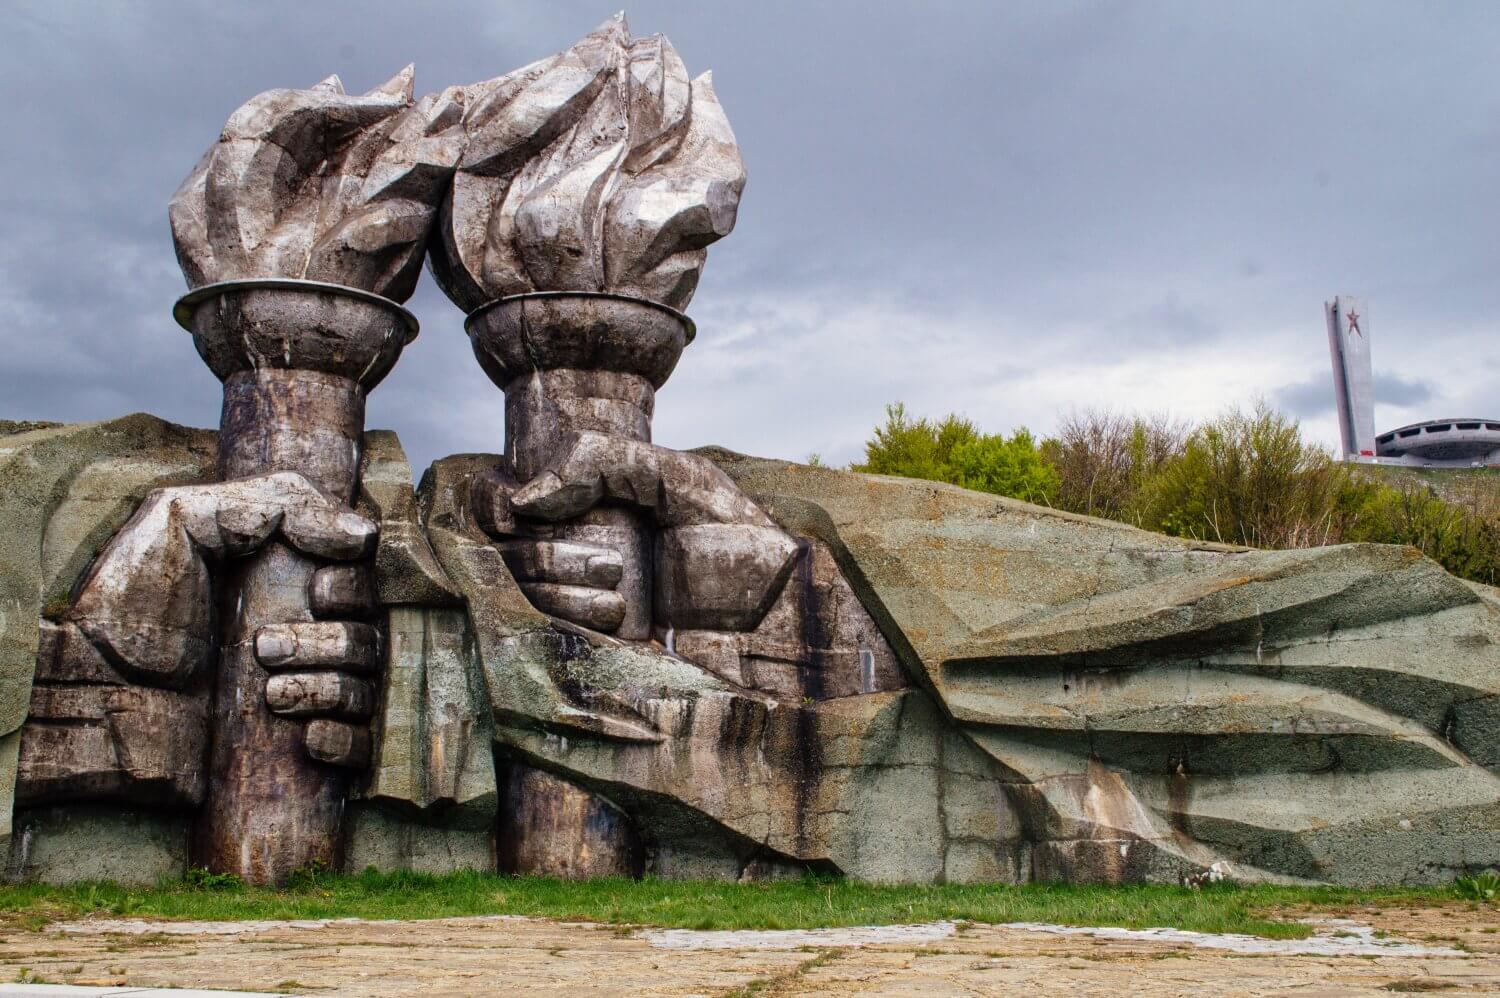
[852,402,1500,585]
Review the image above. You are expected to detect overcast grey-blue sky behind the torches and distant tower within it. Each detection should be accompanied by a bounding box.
[0,0,1500,473]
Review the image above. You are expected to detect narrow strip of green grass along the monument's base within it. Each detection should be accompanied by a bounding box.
[0,870,1455,938]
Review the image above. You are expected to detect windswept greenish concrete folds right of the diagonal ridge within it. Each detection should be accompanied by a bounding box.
[713,452,1500,884]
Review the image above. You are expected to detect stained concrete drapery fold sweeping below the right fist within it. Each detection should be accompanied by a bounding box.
[422,455,1028,881]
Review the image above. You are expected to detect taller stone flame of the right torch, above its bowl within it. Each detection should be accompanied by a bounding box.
[432,15,746,312]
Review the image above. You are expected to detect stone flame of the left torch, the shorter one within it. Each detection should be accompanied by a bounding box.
[170,66,464,302]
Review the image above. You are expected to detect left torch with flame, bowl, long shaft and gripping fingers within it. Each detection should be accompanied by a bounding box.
[161,68,462,882]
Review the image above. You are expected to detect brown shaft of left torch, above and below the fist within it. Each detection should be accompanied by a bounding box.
[197,369,365,884]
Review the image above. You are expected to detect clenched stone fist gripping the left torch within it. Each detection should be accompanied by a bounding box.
[69,471,381,765]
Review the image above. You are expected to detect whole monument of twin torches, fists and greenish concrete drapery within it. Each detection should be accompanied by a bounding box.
[0,18,1500,884]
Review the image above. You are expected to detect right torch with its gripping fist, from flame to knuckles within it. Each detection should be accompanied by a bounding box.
[432,15,794,641]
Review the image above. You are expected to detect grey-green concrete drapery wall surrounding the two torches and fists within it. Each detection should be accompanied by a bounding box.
[0,417,1500,882]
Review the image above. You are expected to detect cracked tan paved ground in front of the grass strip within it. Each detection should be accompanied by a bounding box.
[0,905,1500,998]
